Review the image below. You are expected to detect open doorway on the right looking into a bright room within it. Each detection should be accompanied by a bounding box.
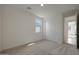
[64,16,77,45]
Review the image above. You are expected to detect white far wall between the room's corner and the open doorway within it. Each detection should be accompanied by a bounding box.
[46,12,64,44]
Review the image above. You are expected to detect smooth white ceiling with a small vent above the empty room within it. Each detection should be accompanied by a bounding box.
[5,4,79,17]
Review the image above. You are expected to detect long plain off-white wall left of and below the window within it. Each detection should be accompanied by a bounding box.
[3,6,42,49]
